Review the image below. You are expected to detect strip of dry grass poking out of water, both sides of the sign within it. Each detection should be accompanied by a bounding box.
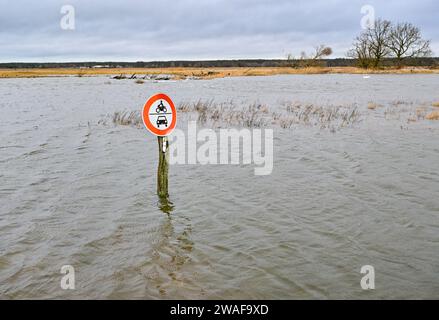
[109,100,439,132]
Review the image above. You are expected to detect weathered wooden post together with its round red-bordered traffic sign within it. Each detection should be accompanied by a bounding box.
[142,93,177,199]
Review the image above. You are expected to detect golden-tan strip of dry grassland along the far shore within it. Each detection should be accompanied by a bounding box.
[0,67,439,80]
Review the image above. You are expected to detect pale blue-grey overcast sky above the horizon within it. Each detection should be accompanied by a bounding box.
[0,0,439,62]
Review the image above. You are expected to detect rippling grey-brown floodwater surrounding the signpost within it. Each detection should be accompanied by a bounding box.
[0,75,439,299]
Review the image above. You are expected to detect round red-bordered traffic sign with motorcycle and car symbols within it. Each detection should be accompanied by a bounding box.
[142,93,177,136]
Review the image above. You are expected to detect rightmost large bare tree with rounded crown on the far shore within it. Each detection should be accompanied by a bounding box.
[387,23,432,66]
